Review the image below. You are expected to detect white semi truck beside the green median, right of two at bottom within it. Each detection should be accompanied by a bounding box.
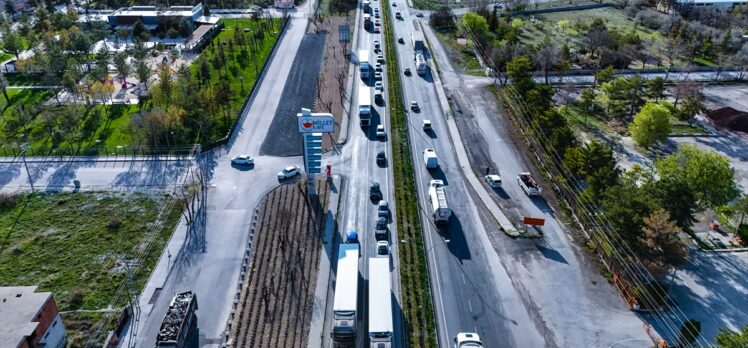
[369,257,392,348]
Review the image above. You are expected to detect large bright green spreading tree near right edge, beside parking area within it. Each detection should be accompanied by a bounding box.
[655,144,740,211]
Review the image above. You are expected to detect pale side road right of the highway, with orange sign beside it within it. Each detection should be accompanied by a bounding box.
[429,17,651,347]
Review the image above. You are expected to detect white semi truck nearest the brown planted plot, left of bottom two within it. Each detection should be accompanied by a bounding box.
[330,243,359,342]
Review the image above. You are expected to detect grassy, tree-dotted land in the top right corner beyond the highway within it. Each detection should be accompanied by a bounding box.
[457,1,748,74]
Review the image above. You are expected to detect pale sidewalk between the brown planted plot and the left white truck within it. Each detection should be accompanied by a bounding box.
[307,175,342,348]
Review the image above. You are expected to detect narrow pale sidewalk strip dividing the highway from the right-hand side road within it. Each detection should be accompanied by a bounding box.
[421,23,519,237]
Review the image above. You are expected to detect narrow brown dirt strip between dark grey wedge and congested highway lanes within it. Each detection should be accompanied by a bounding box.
[312,17,354,149]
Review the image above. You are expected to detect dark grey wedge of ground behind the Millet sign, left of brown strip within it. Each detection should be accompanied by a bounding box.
[260,32,327,156]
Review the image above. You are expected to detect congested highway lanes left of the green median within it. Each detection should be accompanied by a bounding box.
[323,1,402,347]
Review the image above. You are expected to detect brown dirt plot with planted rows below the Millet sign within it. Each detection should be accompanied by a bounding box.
[231,180,329,347]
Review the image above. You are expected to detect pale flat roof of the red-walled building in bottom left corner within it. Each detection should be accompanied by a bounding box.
[0,286,52,345]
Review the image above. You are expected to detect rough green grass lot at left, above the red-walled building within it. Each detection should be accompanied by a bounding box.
[0,192,181,311]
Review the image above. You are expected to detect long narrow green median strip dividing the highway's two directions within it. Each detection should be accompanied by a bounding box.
[382,0,437,347]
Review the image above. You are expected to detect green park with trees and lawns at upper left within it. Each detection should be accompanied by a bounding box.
[0,12,282,154]
